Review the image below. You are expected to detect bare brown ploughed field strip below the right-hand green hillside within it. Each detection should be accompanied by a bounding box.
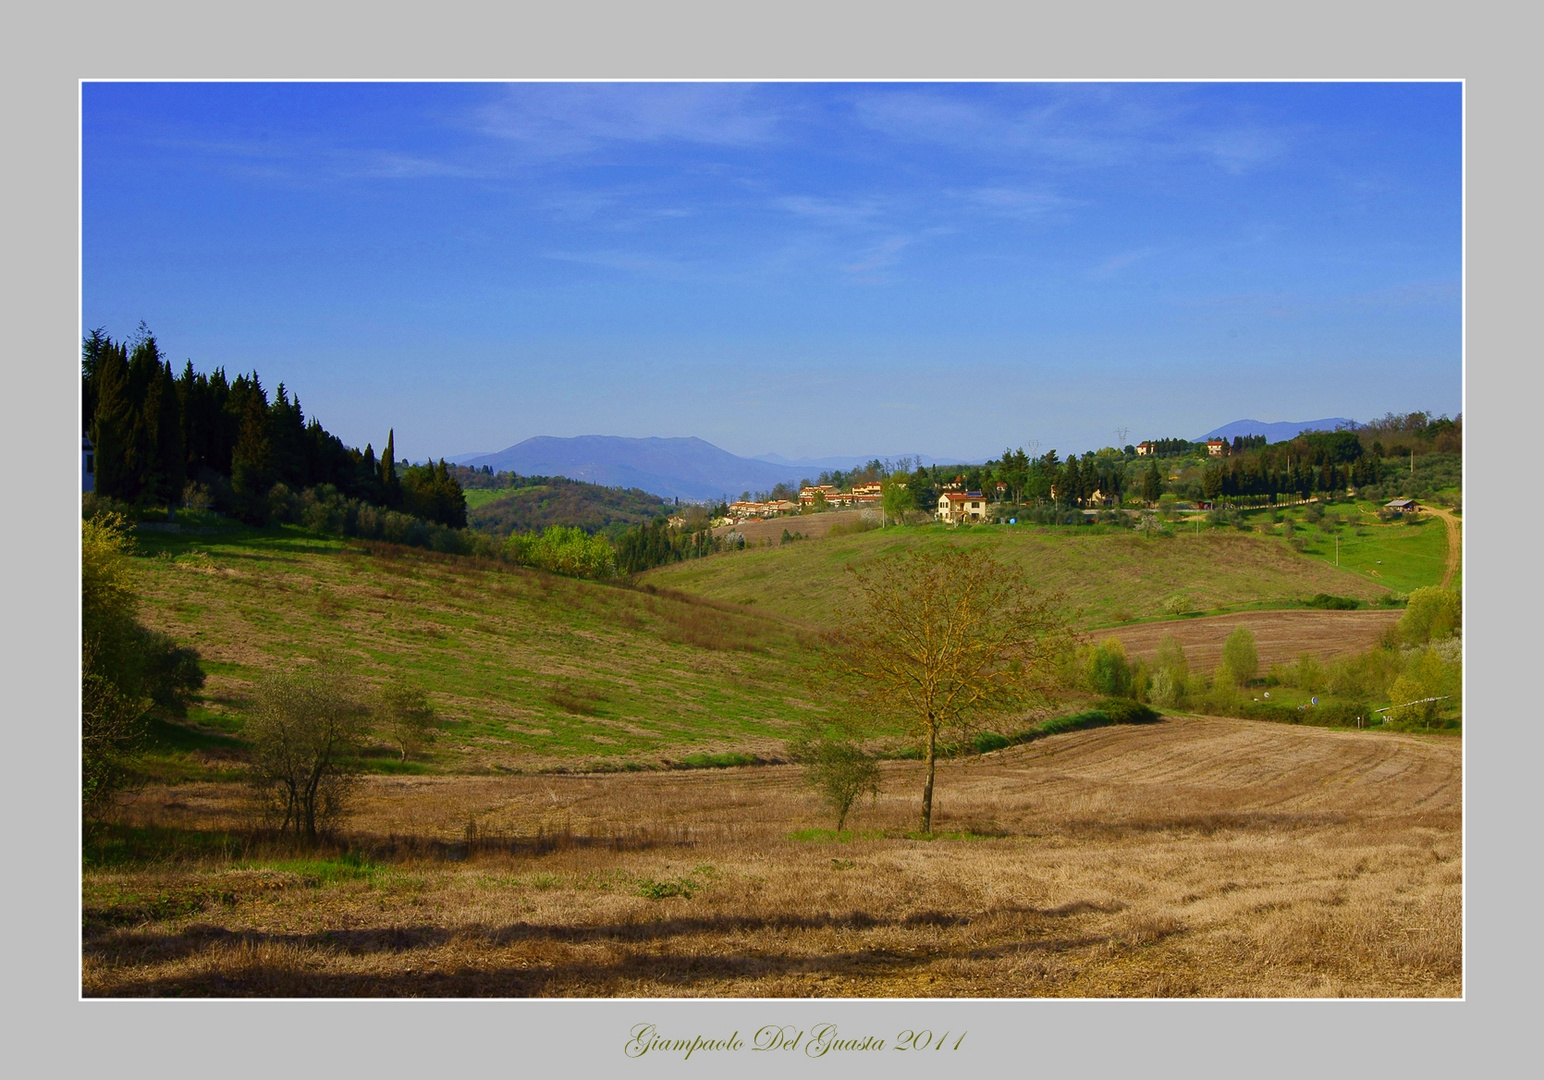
[1093,610,1402,671]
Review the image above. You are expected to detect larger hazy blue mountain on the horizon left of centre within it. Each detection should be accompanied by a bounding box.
[457,436,820,501]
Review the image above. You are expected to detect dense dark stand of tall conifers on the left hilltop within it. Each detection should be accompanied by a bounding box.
[80,324,466,527]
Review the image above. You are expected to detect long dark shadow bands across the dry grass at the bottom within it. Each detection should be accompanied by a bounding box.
[85,901,1122,997]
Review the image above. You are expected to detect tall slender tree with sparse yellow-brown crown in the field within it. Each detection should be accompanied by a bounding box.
[832,547,1073,833]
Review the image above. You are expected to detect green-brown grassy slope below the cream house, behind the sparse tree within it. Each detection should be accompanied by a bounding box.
[644,525,1389,627]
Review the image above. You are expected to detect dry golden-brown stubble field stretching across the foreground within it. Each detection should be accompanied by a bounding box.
[82,720,1462,997]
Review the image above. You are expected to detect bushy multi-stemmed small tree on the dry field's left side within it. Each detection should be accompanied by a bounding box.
[242,671,369,839]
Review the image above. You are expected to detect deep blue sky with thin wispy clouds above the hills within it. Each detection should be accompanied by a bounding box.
[82,83,1462,459]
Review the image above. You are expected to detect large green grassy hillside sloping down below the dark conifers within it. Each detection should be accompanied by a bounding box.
[134,527,817,768]
